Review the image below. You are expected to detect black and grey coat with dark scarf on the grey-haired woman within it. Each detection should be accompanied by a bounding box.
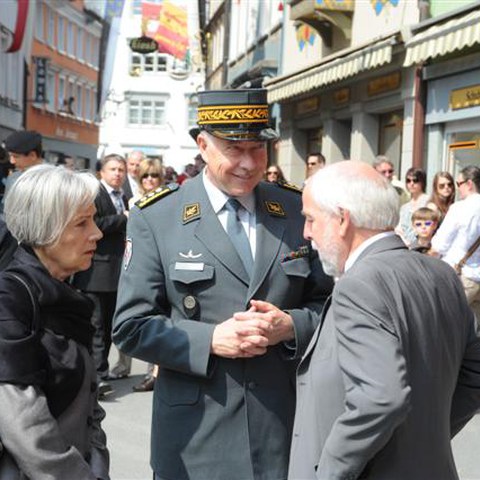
[0,247,109,480]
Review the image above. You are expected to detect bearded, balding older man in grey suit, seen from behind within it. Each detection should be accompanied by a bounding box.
[289,161,480,480]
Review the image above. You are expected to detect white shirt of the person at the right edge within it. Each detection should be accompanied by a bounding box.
[432,193,480,282]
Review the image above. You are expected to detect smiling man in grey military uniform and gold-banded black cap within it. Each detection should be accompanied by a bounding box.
[113,90,332,480]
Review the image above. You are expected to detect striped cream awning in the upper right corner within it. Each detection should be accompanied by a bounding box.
[403,10,480,67]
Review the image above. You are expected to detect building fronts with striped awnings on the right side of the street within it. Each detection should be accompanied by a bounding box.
[204,0,480,188]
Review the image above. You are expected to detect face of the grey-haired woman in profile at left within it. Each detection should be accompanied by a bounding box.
[34,203,103,281]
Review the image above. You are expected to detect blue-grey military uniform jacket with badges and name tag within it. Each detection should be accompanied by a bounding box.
[113,175,332,480]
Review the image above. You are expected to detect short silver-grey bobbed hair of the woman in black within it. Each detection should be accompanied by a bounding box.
[5,165,99,247]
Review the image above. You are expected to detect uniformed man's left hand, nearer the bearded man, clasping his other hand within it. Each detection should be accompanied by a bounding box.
[233,300,295,349]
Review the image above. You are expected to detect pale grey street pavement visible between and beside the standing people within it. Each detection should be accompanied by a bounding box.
[102,356,480,480]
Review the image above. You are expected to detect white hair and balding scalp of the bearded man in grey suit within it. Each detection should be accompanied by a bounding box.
[308,160,400,231]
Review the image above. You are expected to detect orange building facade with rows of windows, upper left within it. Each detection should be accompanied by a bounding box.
[25,0,103,168]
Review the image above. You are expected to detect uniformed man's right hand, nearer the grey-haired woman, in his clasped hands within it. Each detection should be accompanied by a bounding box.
[211,314,272,358]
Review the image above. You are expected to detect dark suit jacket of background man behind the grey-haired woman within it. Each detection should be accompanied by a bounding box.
[73,185,127,292]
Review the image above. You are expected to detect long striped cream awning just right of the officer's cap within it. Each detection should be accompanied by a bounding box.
[265,37,394,103]
